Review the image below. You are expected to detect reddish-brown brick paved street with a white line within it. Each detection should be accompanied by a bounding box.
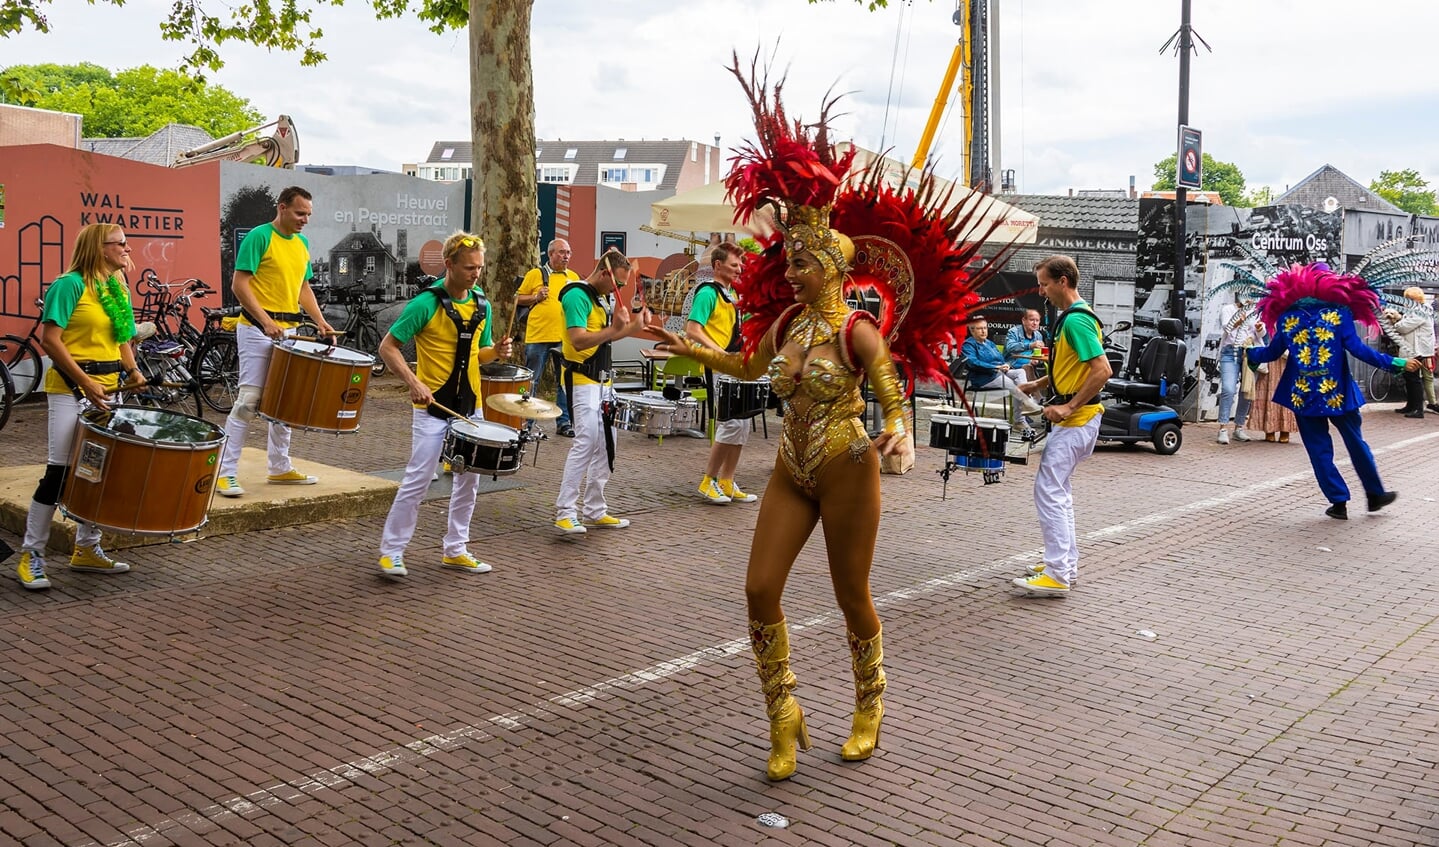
[0,384,1439,847]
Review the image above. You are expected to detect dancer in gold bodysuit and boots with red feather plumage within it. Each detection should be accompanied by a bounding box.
[655,58,1001,779]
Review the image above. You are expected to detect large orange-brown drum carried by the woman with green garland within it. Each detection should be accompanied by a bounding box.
[60,406,224,535]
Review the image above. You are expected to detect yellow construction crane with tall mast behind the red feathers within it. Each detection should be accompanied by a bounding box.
[914,0,999,191]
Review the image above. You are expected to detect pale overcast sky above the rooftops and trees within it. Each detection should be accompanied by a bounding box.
[8,0,1439,193]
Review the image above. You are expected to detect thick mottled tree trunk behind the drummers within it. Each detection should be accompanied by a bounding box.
[469,0,540,345]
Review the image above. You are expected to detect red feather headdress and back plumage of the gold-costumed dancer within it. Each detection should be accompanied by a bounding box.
[725,55,1010,387]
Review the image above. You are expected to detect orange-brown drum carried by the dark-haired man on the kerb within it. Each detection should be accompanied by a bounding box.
[259,338,374,433]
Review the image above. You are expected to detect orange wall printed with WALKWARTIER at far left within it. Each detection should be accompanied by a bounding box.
[0,144,220,335]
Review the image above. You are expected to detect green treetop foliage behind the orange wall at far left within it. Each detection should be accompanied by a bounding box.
[0,62,263,138]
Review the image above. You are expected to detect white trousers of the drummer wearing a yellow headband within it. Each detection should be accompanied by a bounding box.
[380,408,482,557]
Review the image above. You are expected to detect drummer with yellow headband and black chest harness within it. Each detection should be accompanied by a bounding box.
[380,233,511,578]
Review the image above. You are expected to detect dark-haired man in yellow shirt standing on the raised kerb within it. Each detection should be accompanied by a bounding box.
[214,186,338,498]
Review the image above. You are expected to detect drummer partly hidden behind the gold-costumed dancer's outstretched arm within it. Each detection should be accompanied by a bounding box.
[685,243,758,503]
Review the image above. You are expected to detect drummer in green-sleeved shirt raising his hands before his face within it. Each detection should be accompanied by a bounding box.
[554,247,643,534]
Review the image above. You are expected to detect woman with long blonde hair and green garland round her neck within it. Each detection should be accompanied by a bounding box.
[16,223,145,591]
